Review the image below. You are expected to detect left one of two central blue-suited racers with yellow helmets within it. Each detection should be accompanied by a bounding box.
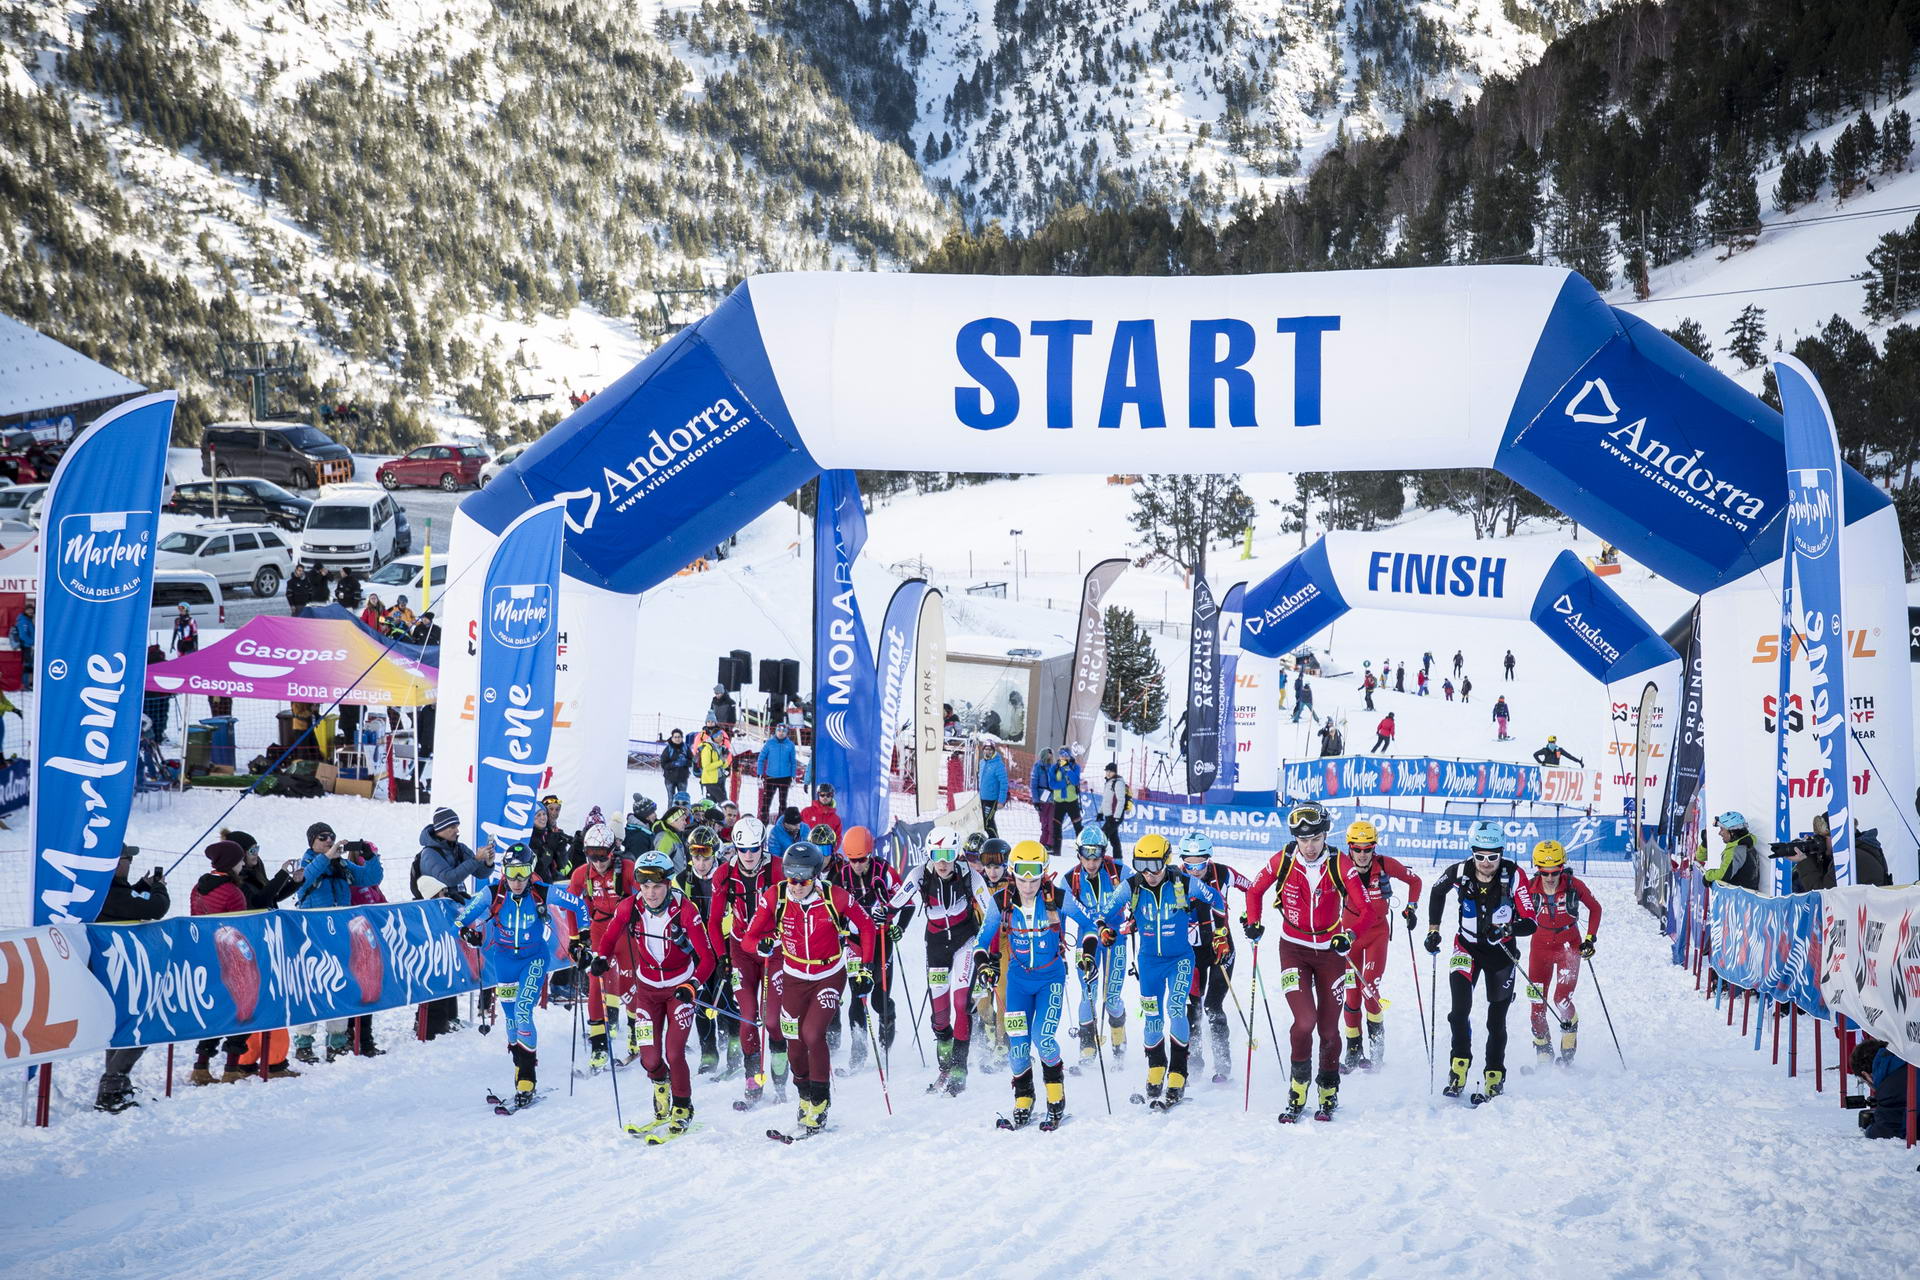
[973,841,1094,1130]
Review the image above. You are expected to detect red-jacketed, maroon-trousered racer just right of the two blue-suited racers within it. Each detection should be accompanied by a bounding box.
[1240,802,1363,1125]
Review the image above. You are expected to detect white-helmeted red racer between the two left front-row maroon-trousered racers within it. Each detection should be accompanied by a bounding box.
[707,818,787,1111]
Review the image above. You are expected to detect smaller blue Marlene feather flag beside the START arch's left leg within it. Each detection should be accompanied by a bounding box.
[474,503,566,844]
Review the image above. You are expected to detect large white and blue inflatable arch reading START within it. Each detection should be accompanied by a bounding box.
[440,267,1912,875]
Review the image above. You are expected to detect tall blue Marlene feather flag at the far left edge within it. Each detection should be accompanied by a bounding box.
[31,391,175,925]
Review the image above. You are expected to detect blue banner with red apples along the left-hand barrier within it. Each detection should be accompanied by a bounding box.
[86,890,572,1048]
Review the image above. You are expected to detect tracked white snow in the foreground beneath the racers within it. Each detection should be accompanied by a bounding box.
[0,867,1916,1276]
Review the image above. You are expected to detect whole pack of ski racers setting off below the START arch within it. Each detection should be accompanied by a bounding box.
[459,800,1601,1144]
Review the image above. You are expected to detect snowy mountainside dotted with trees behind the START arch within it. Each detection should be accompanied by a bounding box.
[0,0,1611,447]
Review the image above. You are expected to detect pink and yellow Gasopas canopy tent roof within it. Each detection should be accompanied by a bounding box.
[146,616,440,706]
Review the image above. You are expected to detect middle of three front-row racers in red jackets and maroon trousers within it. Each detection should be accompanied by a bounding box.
[745,842,874,1134]
